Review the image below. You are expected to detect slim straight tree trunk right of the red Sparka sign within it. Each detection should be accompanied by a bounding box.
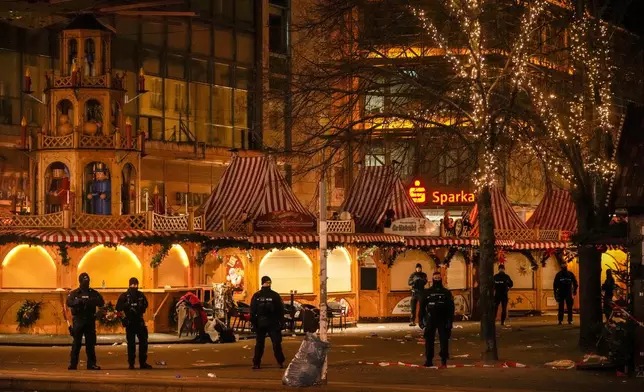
[478,186,499,361]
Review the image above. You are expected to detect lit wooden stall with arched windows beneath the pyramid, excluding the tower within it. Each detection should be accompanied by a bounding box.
[0,217,245,334]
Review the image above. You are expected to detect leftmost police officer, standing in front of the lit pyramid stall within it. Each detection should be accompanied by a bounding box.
[67,272,105,370]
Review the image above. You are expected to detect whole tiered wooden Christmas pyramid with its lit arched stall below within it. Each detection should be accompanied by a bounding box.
[0,14,246,334]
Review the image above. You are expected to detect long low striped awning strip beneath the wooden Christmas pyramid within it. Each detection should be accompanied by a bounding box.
[0,229,172,244]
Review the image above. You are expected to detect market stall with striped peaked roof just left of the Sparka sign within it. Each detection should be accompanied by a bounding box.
[342,166,469,320]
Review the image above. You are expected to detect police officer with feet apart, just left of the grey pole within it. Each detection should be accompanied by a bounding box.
[250,276,285,369]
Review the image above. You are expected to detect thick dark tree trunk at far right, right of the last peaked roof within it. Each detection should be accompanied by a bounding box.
[576,200,603,351]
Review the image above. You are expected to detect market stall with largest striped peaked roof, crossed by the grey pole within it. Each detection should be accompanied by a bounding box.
[200,156,403,321]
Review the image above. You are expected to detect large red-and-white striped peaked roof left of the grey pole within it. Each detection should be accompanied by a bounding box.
[199,155,313,232]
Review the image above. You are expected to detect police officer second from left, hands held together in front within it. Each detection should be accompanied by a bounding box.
[116,278,152,369]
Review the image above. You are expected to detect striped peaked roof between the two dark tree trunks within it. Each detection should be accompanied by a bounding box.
[526,189,577,232]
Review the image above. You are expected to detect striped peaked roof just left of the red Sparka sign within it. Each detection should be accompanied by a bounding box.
[342,166,424,232]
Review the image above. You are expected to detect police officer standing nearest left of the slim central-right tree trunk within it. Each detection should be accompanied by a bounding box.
[420,271,454,367]
